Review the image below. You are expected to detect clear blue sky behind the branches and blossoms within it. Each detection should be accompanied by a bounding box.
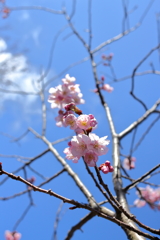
[0,0,160,240]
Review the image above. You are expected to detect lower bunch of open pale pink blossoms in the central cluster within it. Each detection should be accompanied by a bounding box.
[64,133,110,167]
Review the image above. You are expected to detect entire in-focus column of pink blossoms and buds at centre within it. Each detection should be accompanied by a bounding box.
[48,74,113,173]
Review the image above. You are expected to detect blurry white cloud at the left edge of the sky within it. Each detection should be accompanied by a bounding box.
[0,39,39,104]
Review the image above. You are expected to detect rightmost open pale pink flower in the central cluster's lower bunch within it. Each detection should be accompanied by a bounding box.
[88,133,110,156]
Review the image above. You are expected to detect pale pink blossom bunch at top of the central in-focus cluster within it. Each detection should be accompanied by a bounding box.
[48,74,84,109]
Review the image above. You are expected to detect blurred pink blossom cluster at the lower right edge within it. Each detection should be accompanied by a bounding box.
[134,186,160,210]
